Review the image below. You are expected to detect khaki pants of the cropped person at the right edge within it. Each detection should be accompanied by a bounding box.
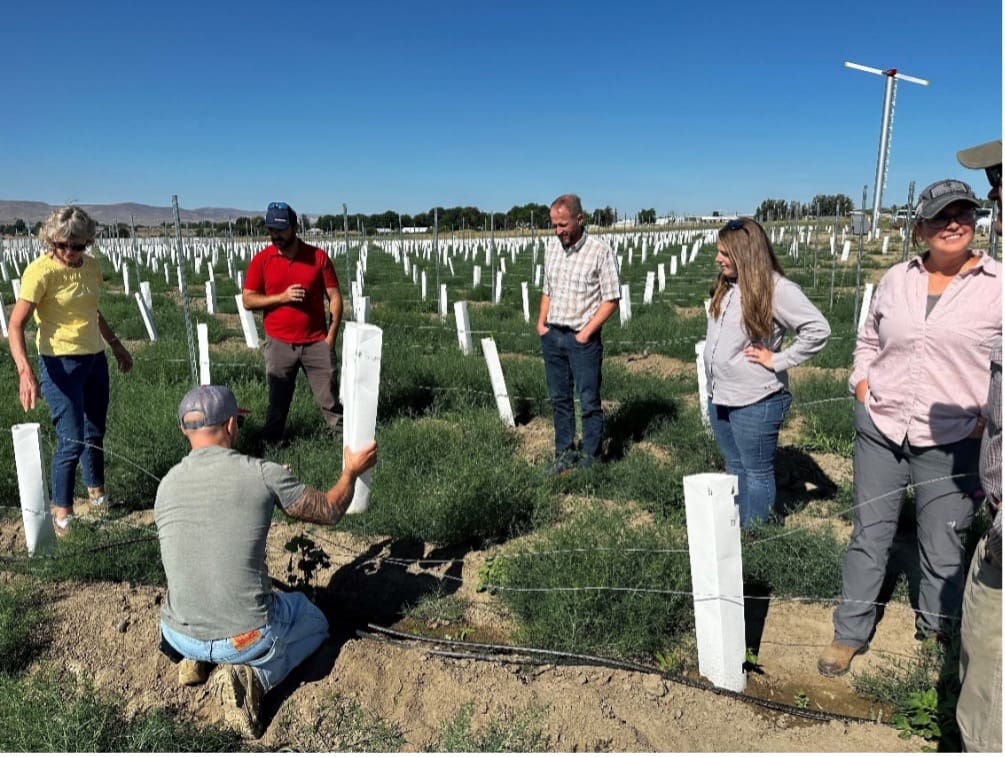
[956,536,1002,752]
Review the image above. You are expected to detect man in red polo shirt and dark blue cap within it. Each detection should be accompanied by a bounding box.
[241,202,342,444]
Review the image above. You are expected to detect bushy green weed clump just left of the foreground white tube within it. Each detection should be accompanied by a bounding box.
[482,503,693,660]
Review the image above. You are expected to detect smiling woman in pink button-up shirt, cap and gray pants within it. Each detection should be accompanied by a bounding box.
[817,179,1002,676]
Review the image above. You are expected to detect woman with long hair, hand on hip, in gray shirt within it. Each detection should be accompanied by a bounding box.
[705,218,830,528]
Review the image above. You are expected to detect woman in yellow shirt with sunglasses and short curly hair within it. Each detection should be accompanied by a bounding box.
[10,205,133,533]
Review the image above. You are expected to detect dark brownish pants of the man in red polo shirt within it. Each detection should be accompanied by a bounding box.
[261,337,342,442]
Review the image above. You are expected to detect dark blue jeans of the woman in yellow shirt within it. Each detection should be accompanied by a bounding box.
[38,352,109,508]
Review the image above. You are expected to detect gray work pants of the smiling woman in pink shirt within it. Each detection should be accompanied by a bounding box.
[834,402,980,646]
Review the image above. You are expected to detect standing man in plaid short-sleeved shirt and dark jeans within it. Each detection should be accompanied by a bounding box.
[538,194,621,476]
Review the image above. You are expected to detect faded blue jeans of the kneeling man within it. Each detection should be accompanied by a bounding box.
[161,591,328,692]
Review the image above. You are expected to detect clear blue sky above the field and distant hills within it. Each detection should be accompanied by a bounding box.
[0,0,1002,214]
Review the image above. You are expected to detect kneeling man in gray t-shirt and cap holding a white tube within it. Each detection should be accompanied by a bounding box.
[154,386,377,738]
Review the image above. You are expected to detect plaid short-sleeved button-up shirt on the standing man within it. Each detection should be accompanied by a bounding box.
[542,230,621,331]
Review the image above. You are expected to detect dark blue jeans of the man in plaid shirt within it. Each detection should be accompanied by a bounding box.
[541,326,604,461]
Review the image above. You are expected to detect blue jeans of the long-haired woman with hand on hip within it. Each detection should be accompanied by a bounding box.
[709,390,792,528]
